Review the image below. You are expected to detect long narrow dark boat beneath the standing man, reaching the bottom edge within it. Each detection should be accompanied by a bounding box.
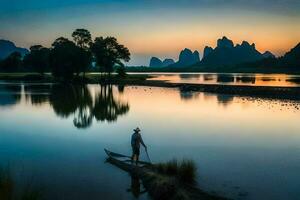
[104,149,225,200]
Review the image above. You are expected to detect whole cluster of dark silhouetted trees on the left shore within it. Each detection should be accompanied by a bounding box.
[0,29,130,79]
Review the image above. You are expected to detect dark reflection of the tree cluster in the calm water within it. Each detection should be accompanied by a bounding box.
[25,84,129,129]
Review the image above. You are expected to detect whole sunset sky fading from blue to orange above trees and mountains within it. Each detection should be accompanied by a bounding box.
[0,0,300,65]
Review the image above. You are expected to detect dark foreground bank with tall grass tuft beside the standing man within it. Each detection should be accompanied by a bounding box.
[107,157,226,200]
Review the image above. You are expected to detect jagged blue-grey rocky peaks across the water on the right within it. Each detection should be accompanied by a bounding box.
[149,36,275,67]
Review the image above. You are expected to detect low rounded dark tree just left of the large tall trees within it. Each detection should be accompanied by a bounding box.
[24,45,50,75]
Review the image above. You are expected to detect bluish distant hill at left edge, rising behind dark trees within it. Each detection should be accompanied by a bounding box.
[0,40,29,60]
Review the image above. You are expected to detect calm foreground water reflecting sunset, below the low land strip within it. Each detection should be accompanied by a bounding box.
[0,83,300,200]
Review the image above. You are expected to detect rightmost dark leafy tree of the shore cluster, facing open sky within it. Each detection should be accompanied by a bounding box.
[91,37,130,75]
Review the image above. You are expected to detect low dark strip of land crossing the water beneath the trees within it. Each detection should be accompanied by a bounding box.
[0,73,300,100]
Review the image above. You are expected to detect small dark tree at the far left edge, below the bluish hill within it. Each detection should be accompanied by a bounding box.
[0,52,22,72]
